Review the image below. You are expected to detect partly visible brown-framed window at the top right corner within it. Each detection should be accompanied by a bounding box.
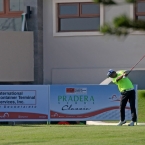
[135,0,145,20]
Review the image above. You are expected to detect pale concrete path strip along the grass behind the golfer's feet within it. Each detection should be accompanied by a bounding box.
[86,121,145,126]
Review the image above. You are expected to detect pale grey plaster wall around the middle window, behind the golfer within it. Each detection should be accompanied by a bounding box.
[43,0,145,87]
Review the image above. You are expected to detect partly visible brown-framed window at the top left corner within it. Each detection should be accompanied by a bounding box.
[0,0,24,18]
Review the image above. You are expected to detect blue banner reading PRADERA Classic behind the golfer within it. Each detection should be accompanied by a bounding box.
[50,85,137,121]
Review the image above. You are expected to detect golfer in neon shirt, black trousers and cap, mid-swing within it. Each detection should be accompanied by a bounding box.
[107,69,137,126]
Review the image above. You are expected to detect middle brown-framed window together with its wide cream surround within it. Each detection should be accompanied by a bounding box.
[53,0,104,36]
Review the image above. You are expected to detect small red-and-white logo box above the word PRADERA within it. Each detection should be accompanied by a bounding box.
[66,88,87,94]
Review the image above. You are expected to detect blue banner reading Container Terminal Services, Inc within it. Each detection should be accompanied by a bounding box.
[0,85,49,121]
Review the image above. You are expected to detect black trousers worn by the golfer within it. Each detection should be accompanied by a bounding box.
[120,90,137,122]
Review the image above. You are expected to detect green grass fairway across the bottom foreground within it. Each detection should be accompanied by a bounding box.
[0,125,145,145]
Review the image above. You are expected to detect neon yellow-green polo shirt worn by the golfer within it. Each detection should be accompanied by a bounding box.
[112,70,134,92]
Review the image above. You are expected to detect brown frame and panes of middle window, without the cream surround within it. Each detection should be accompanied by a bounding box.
[58,3,100,32]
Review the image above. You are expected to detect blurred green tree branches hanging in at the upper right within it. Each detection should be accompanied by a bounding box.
[94,0,145,36]
